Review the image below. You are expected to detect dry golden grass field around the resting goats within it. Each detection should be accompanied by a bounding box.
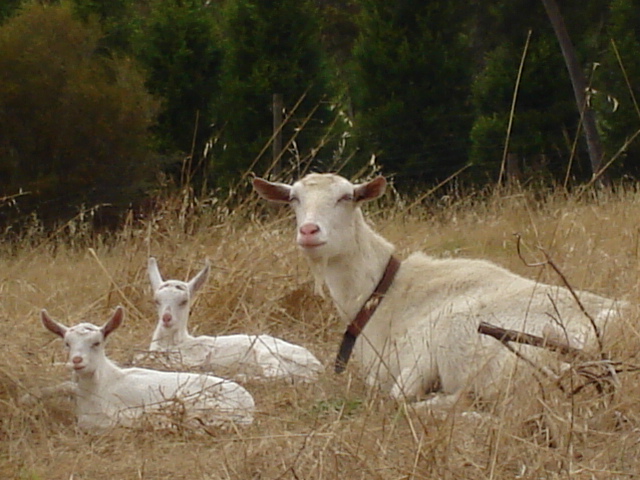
[0,182,640,480]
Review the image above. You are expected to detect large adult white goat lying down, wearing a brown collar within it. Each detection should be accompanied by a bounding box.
[253,174,618,406]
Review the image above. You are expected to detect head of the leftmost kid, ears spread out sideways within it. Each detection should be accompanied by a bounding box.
[40,307,124,375]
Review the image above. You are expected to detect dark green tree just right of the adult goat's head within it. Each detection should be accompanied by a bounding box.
[351,0,472,188]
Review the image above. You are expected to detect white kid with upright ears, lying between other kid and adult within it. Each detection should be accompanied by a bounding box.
[148,257,323,382]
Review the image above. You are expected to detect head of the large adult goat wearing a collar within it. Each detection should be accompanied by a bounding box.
[253,173,387,258]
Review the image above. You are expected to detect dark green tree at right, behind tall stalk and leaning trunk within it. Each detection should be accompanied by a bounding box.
[470,0,606,182]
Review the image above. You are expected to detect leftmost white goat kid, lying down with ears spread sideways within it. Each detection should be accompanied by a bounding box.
[41,307,255,431]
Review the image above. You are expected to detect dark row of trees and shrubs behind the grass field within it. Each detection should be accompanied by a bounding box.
[0,0,640,231]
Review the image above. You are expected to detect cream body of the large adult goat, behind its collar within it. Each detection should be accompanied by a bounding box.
[357,253,619,395]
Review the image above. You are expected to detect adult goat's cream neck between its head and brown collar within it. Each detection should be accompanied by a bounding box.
[312,216,394,324]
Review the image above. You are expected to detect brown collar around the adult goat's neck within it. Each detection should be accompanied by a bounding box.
[335,255,400,373]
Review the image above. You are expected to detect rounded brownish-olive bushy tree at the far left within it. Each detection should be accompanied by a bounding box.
[0,3,156,227]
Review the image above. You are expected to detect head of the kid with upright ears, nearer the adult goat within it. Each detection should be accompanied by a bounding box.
[148,257,210,329]
